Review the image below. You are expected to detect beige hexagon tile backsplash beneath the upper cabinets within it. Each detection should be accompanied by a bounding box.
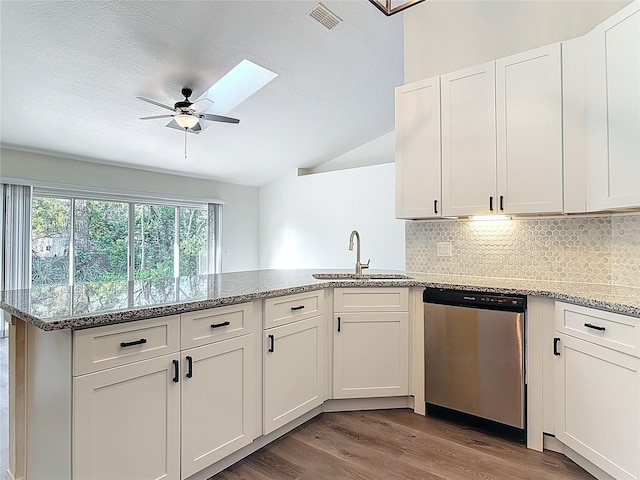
[405,213,640,288]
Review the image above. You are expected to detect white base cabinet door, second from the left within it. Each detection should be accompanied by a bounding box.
[181,334,260,479]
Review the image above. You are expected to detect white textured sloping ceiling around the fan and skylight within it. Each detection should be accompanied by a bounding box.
[0,0,403,185]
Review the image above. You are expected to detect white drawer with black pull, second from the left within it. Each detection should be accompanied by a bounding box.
[180,303,260,349]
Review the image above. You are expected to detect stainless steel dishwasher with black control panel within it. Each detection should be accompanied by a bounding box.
[423,288,526,440]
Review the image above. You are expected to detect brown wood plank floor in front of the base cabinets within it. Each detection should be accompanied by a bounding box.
[213,409,594,480]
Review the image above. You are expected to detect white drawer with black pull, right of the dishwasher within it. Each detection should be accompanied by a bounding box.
[556,302,640,357]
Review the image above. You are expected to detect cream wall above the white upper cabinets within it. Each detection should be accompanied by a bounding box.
[403,0,630,83]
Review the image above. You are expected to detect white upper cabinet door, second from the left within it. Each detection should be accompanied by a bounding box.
[441,62,497,216]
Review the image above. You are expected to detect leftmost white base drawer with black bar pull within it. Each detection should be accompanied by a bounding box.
[73,315,180,376]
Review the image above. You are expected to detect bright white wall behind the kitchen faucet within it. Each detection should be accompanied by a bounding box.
[260,163,405,270]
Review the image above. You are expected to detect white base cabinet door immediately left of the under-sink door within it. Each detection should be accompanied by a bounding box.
[262,316,326,435]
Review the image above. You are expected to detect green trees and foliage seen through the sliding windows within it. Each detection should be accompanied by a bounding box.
[32,197,208,285]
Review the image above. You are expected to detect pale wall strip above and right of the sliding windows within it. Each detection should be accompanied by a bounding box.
[0,149,259,272]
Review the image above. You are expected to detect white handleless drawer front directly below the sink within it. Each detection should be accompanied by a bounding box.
[333,287,409,312]
